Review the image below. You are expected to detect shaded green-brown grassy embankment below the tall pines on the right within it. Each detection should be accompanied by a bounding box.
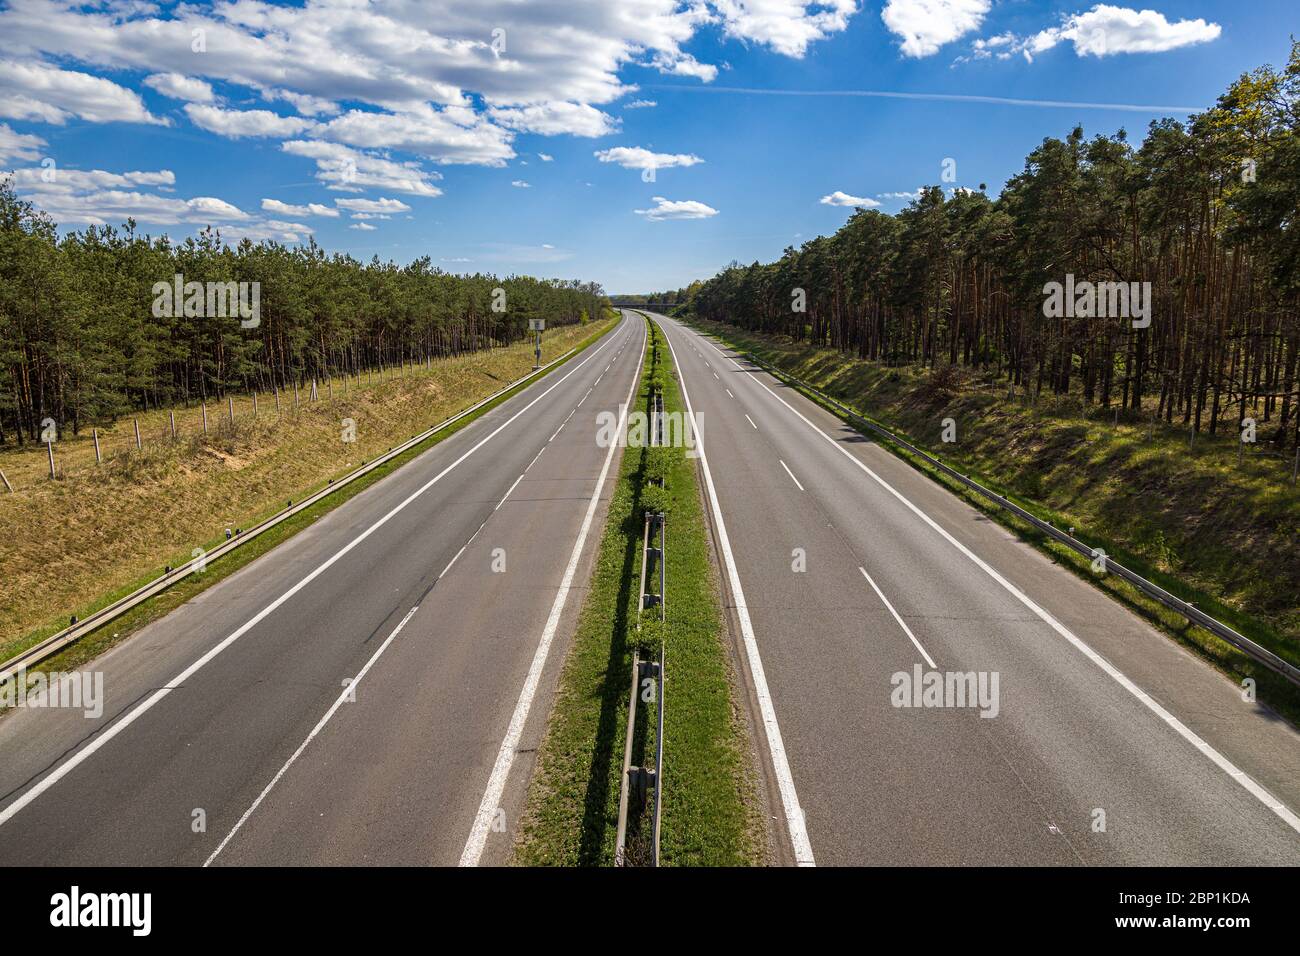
[692,320,1300,721]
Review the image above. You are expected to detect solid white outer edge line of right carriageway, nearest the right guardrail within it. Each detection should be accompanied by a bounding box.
[705,319,1300,832]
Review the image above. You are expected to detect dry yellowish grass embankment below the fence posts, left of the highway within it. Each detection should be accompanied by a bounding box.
[0,317,615,667]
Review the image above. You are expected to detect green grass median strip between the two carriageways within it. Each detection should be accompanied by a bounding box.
[515,316,767,866]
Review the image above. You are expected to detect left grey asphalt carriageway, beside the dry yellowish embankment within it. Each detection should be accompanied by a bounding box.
[0,316,645,866]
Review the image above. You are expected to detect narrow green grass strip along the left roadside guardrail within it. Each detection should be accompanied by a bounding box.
[0,323,614,697]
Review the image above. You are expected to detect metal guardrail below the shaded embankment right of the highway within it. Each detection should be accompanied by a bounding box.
[742,352,1300,687]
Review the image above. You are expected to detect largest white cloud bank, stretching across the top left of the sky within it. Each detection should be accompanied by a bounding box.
[0,0,733,128]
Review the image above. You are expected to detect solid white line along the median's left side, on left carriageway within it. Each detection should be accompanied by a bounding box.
[460,316,646,866]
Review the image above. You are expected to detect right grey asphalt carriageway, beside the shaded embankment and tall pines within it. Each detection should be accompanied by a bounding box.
[654,316,1300,866]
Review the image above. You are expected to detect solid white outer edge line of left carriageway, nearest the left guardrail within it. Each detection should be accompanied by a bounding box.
[0,317,629,826]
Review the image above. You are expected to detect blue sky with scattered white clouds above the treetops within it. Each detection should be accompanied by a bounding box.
[0,0,1300,293]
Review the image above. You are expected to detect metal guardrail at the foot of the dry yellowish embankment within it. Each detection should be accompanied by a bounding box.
[0,335,598,684]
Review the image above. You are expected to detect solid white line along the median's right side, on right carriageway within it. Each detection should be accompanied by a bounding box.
[655,321,816,866]
